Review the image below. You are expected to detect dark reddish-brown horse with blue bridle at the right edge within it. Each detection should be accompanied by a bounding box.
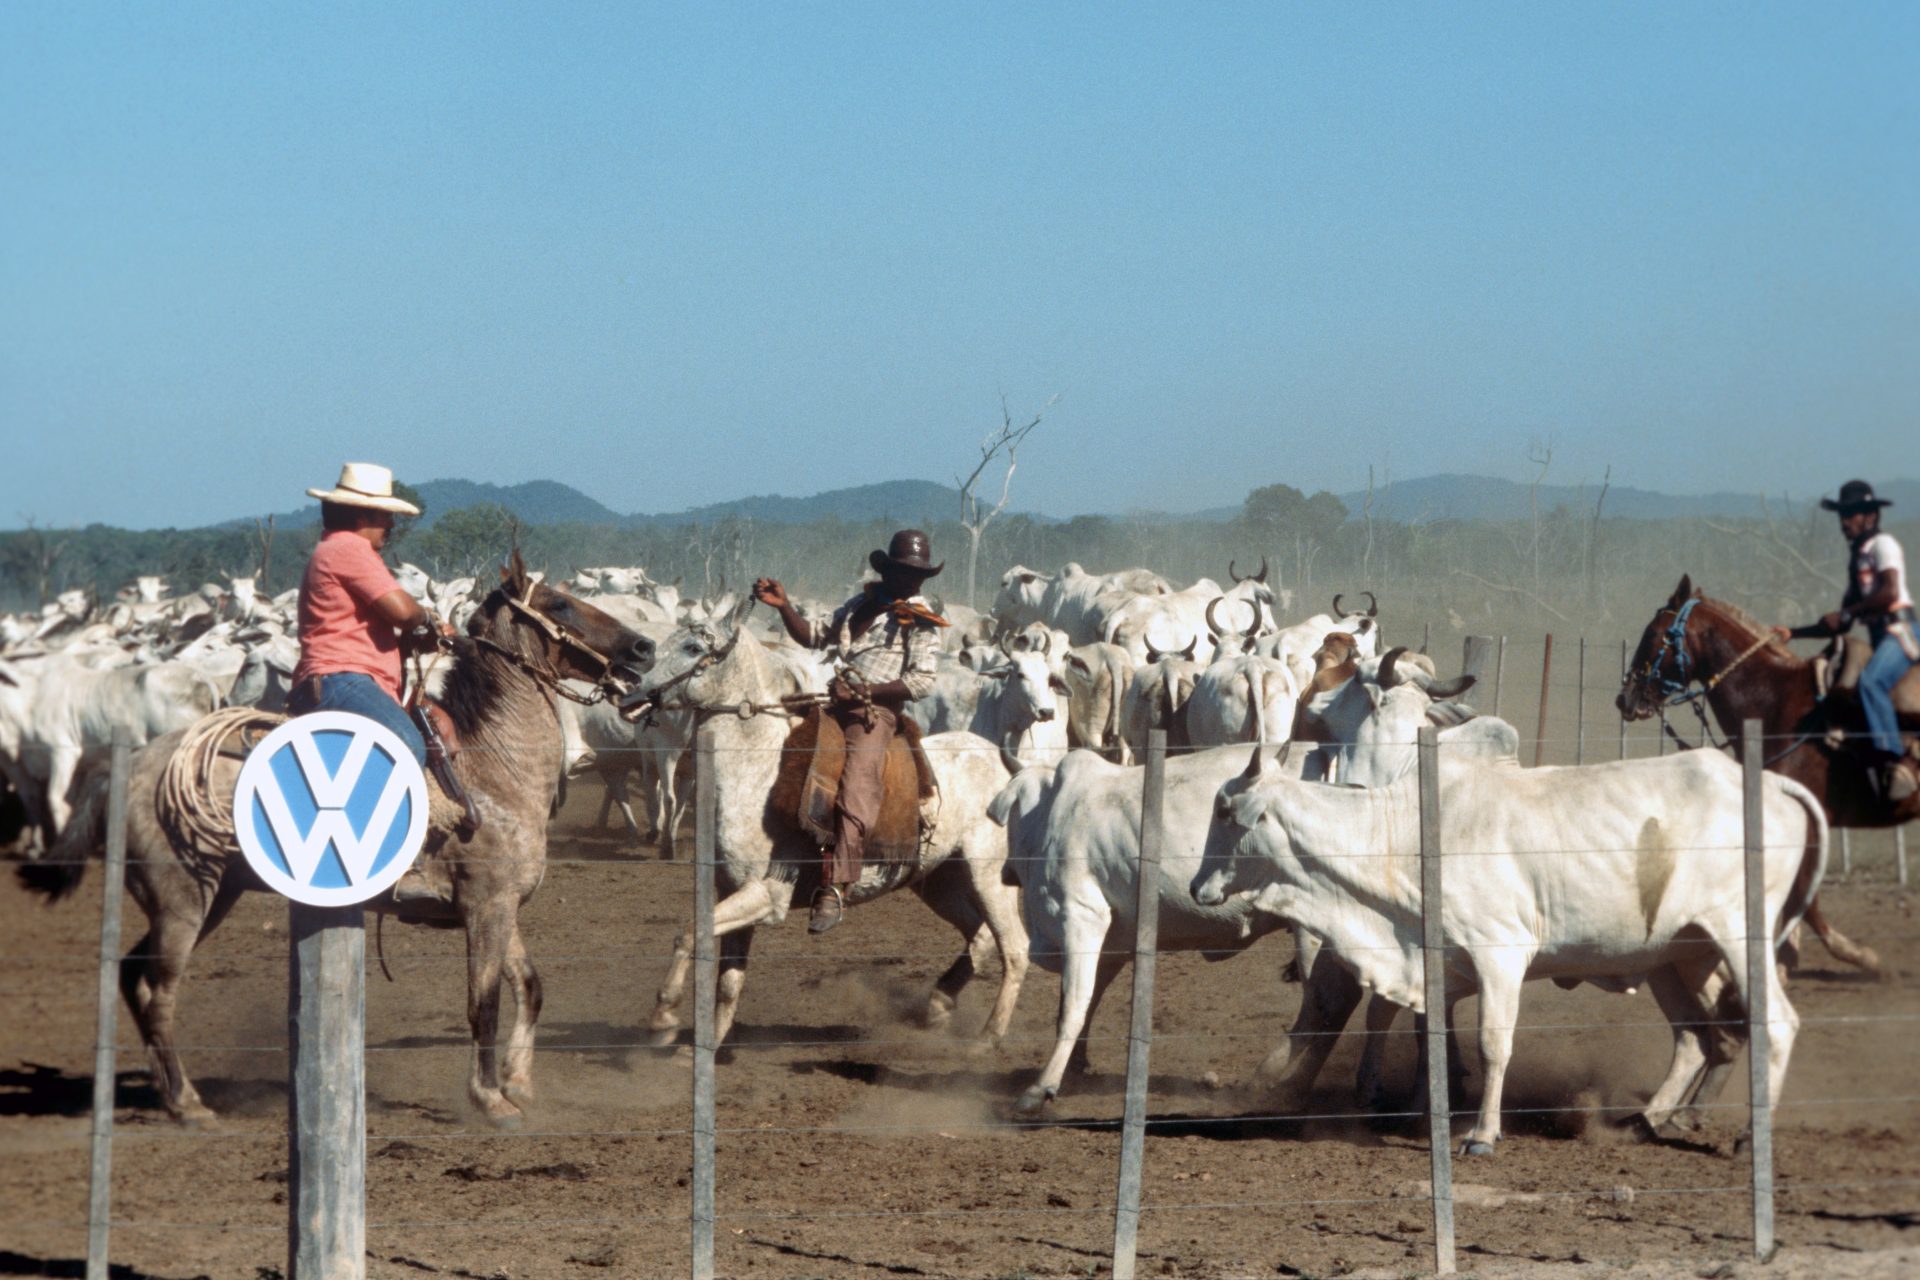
[1615,576,1920,973]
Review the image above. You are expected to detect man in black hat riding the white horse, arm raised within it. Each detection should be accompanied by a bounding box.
[753,530,947,933]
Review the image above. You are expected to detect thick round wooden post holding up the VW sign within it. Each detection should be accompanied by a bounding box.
[286,900,367,1280]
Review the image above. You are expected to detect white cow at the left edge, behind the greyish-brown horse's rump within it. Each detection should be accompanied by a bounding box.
[0,654,221,837]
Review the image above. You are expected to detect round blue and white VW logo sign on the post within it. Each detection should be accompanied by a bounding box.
[234,712,426,906]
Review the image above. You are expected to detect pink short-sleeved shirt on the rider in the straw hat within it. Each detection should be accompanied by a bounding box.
[294,530,399,702]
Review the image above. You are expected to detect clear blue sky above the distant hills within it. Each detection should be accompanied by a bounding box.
[0,0,1920,526]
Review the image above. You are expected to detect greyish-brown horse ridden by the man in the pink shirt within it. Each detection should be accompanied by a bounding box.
[19,551,639,1125]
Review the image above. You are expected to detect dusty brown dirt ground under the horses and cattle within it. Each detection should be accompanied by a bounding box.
[0,787,1920,1280]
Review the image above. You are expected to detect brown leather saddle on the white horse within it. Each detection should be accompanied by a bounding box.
[770,706,939,862]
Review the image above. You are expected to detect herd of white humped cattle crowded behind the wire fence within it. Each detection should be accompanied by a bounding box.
[0,564,1828,1151]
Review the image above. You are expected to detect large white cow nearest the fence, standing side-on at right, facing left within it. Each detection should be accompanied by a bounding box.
[1192,721,1828,1155]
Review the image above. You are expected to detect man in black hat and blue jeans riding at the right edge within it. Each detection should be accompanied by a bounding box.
[1774,480,1920,802]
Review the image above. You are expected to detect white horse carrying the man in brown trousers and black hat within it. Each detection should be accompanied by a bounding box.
[626,624,1027,1046]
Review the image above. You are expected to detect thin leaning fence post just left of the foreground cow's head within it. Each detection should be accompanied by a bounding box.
[1114,729,1167,1280]
